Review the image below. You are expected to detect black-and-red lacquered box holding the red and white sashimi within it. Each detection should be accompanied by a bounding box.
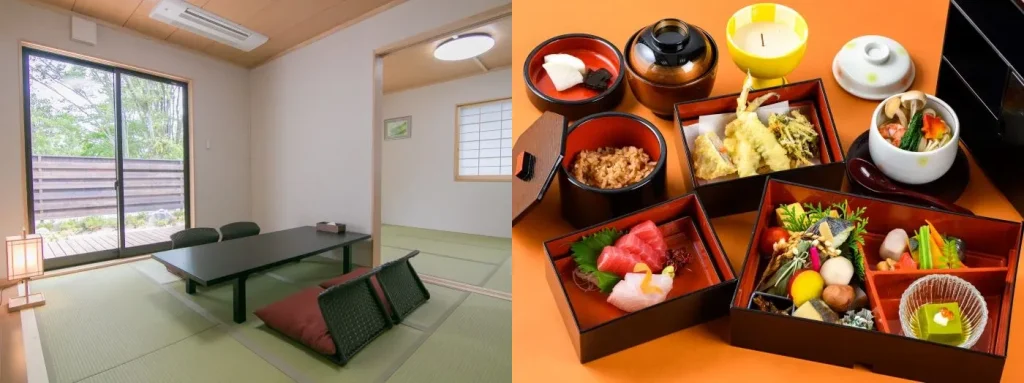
[544,194,736,363]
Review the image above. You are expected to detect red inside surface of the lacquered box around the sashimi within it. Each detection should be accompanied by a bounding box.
[555,217,722,331]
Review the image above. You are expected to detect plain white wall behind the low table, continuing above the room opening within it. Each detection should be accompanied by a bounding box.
[250,0,510,240]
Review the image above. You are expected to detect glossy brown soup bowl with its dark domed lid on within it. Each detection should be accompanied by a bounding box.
[624,18,719,120]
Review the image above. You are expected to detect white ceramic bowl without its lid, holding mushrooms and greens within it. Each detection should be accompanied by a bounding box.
[867,94,959,184]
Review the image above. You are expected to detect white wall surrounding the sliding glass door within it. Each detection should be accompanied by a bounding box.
[0,0,251,280]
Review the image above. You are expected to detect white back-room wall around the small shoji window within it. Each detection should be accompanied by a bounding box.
[381,67,512,238]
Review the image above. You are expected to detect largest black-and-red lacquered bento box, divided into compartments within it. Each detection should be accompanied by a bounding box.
[730,179,1022,382]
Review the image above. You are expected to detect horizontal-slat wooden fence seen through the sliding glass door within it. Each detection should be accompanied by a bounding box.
[32,156,184,220]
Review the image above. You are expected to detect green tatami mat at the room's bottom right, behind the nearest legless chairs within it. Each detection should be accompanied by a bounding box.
[388,294,512,382]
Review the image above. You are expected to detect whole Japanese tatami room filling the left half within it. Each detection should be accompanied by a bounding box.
[0,0,512,383]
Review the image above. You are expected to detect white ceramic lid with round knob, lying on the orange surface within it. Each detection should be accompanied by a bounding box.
[833,36,916,99]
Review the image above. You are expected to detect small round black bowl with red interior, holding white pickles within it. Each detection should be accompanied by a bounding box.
[522,34,626,121]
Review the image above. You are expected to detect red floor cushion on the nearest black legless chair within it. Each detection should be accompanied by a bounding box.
[255,287,337,355]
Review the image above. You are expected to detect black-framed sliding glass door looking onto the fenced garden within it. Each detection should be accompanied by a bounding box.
[23,47,190,269]
